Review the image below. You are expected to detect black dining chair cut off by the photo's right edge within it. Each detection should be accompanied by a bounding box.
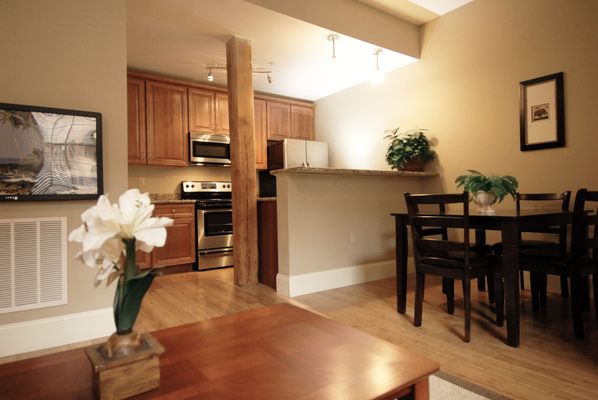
[519,189,598,339]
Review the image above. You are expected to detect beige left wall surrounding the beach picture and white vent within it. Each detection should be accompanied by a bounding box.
[0,0,127,324]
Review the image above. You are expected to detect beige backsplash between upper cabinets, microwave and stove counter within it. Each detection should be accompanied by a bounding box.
[129,165,230,195]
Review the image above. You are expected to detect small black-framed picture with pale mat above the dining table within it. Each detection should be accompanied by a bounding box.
[519,72,565,151]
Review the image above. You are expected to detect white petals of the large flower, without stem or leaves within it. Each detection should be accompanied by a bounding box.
[69,189,173,286]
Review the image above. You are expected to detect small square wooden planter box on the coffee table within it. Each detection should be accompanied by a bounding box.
[85,333,164,400]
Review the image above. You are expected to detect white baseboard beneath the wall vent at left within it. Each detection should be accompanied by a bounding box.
[0,307,115,357]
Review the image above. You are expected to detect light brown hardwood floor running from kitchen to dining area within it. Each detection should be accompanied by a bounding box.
[0,269,598,399]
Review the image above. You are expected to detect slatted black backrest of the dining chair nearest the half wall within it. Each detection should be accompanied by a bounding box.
[405,192,469,268]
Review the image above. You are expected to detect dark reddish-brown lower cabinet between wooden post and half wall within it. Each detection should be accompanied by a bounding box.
[257,200,278,289]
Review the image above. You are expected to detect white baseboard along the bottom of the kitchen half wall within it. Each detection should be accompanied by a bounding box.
[276,260,395,297]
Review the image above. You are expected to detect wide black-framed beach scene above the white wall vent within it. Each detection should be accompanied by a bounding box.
[0,103,104,201]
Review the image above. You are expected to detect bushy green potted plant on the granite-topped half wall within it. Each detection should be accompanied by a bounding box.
[384,128,436,171]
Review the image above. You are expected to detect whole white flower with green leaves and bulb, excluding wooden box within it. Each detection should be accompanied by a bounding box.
[69,189,173,358]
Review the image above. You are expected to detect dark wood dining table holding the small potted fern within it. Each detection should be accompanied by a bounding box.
[391,210,573,347]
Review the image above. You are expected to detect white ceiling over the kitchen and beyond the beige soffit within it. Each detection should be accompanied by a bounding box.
[127,0,470,100]
